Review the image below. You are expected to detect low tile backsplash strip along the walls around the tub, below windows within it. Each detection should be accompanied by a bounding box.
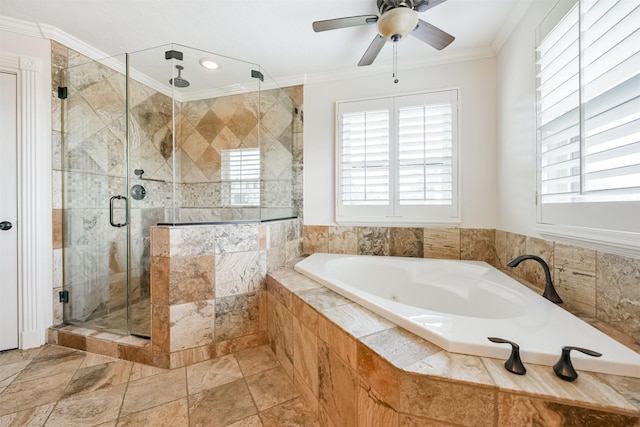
[303,225,640,344]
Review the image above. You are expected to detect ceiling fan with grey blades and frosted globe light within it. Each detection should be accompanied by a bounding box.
[313,0,455,66]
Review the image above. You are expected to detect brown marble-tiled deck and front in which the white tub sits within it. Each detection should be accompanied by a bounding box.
[267,267,640,427]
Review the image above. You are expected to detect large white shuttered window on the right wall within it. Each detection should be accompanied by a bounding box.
[537,0,640,251]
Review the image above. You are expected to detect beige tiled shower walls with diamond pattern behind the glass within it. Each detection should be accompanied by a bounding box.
[52,42,302,334]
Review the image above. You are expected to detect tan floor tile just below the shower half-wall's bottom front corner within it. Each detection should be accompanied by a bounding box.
[120,368,187,417]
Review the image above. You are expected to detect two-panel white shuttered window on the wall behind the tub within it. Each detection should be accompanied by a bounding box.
[336,90,459,224]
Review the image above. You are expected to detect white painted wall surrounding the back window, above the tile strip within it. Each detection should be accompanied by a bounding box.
[304,58,496,228]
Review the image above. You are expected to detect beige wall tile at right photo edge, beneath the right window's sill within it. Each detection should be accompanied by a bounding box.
[596,252,640,343]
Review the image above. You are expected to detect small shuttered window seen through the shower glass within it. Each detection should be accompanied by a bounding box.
[221,148,260,206]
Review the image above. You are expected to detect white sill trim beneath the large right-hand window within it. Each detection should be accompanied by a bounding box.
[534,224,640,259]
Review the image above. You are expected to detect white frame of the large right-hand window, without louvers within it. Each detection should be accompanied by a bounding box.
[536,0,640,257]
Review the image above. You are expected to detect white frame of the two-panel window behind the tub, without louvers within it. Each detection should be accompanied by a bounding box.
[335,88,461,226]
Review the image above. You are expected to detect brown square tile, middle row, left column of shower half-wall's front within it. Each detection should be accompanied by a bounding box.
[169,255,217,305]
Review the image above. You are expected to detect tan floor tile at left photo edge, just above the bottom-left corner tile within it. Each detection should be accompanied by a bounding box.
[0,371,73,416]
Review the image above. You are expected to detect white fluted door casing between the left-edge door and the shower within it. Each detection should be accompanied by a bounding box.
[0,52,53,349]
